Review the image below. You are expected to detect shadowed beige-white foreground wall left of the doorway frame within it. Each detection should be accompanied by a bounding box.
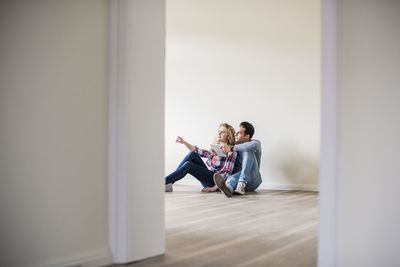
[0,1,111,266]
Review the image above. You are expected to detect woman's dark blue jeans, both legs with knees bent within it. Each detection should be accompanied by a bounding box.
[165,151,215,187]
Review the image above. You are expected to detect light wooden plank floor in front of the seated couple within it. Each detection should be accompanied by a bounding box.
[114,185,318,267]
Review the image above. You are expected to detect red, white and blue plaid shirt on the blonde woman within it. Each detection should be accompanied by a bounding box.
[194,146,237,179]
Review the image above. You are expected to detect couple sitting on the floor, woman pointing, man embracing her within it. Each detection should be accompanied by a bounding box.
[165,121,262,197]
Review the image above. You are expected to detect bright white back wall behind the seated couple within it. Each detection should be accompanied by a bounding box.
[165,0,320,189]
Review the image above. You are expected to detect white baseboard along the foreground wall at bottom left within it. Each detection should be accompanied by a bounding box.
[44,251,113,267]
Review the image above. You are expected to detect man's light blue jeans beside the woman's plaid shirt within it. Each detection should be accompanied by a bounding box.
[226,152,262,192]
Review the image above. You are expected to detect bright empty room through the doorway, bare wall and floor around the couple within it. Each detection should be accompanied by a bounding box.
[161,0,321,266]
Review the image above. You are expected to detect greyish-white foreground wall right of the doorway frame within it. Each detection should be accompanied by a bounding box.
[338,0,400,267]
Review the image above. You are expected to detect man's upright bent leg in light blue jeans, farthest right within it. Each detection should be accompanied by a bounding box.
[238,152,262,191]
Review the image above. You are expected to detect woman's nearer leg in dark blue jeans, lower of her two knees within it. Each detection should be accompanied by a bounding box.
[165,161,214,187]
